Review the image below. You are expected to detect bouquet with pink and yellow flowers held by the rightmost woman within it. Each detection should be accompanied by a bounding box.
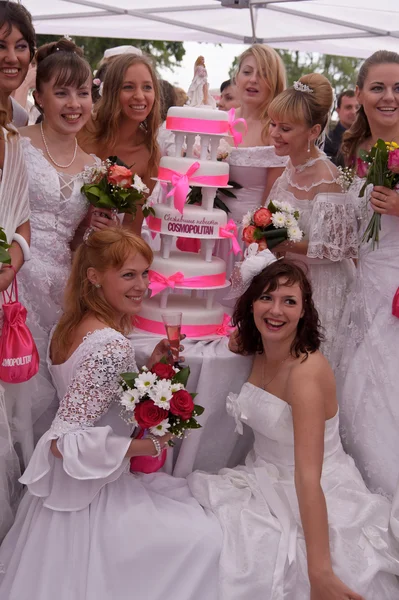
[356,139,399,250]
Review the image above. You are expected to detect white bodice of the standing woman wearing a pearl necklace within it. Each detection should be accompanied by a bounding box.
[21,138,94,263]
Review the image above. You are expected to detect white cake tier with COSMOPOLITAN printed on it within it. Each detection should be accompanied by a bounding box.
[147,204,227,239]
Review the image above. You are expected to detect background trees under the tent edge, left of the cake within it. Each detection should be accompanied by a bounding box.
[37,35,186,70]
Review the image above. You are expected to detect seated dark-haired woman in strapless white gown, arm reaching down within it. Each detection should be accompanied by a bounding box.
[188,250,399,600]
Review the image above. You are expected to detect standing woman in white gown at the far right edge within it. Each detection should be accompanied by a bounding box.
[335,51,399,497]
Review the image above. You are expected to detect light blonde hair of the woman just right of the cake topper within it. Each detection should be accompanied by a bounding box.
[234,44,286,139]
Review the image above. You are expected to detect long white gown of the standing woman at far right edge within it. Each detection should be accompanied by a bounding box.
[334,180,399,497]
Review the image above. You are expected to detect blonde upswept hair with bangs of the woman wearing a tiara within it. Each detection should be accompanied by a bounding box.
[269,73,334,139]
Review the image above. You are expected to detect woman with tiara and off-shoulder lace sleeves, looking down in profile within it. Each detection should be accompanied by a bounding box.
[269,73,358,361]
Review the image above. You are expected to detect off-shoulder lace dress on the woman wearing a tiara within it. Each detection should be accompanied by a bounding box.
[269,154,358,361]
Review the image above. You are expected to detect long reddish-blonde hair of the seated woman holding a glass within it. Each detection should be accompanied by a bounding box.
[52,227,153,360]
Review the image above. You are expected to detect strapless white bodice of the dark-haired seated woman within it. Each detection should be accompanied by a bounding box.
[226,382,342,468]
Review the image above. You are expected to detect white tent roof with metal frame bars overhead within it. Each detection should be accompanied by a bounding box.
[22,0,399,57]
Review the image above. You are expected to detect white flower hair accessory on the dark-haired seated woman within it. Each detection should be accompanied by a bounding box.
[226,242,278,299]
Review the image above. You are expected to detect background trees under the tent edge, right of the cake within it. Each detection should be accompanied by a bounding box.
[229,50,362,93]
